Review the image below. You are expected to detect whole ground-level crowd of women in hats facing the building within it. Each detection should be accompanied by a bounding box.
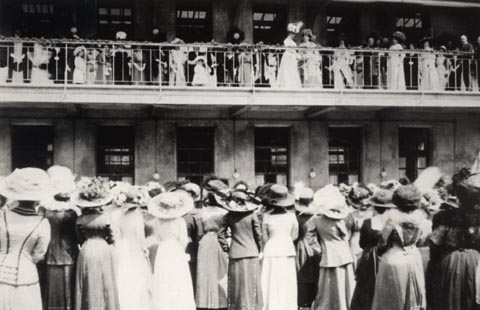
[0,159,480,310]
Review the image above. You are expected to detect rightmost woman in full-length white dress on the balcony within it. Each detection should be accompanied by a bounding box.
[420,38,440,90]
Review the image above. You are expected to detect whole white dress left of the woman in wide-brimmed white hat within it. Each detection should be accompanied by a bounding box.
[115,209,153,310]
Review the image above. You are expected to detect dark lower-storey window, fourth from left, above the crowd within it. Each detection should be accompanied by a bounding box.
[255,127,290,185]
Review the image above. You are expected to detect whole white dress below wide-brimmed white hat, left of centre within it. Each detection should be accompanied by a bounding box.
[153,218,196,310]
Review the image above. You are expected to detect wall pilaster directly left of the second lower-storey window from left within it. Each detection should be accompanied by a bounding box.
[73,119,97,177]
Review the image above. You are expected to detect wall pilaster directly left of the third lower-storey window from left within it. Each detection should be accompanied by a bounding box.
[156,121,177,181]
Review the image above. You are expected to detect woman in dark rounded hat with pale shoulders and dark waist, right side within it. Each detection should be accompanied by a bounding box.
[372,184,431,310]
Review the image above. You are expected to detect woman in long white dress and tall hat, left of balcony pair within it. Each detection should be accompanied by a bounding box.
[277,23,303,89]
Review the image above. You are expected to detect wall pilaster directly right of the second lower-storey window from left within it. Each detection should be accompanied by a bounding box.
[135,120,156,184]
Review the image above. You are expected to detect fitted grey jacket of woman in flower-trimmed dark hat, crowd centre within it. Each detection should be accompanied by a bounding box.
[218,212,262,259]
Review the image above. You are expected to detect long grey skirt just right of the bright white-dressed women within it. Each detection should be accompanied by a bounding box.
[195,232,228,309]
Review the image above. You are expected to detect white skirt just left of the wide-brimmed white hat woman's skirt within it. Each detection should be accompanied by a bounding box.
[117,239,152,310]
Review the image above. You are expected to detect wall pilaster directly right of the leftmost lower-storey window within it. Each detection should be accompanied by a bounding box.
[53,119,75,170]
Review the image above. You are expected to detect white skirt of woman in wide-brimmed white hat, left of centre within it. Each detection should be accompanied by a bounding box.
[153,239,196,310]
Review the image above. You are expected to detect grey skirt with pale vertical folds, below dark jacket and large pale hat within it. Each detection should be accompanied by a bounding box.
[314,264,355,310]
